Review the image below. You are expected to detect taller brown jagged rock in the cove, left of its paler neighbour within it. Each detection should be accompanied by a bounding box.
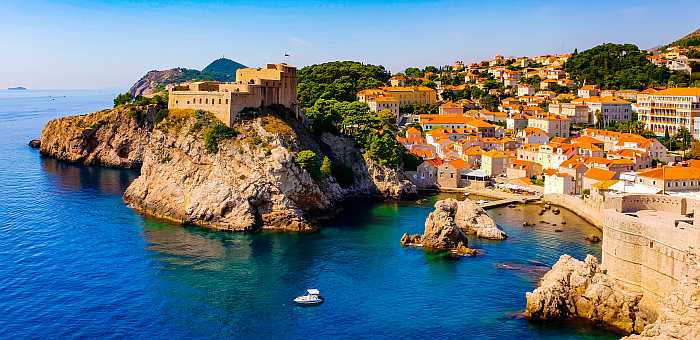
[423,199,468,250]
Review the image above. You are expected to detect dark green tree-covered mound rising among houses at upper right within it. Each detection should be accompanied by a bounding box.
[566,44,671,89]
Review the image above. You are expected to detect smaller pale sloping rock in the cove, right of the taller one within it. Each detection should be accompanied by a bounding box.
[452,199,506,240]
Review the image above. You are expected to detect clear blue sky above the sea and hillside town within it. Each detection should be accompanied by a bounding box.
[0,0,700,90]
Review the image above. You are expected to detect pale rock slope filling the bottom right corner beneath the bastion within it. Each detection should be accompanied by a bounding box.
[625,262,700,340]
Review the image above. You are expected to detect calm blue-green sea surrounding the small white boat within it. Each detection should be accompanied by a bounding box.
[0,91,613,339]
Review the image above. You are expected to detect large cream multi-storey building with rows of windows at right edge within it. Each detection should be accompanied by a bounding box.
[637,87,700,138]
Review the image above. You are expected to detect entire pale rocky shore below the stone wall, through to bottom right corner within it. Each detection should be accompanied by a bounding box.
[525,255,700,339]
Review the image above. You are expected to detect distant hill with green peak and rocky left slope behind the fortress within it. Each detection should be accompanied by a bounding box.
[129,58,245,97]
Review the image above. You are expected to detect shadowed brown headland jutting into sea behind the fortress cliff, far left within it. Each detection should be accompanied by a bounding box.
[37,106,156,168]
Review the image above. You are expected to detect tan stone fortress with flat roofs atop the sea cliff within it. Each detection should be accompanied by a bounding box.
[168,64,298,126]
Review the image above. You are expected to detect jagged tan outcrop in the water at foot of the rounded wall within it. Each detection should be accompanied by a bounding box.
[525,255,653,333]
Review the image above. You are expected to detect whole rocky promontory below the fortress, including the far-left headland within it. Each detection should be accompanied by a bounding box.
[37,106,416,232]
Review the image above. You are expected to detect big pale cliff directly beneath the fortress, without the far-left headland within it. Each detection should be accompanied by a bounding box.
[124,111,415,231]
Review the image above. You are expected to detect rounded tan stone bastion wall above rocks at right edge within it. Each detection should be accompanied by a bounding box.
[602,194,700,306]
